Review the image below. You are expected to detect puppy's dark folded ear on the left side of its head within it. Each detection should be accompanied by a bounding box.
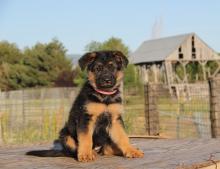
[79,52,96,70]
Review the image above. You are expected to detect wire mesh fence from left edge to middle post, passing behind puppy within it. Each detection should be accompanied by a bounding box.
[0,86,145,144]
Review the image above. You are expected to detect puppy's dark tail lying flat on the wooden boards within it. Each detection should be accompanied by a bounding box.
[26,149,68,157]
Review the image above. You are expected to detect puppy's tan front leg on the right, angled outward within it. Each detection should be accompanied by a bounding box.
[110,118,144,158]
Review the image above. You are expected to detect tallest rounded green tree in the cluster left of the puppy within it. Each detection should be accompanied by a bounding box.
[24,39,72,86]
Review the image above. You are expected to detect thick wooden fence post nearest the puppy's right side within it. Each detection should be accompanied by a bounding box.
[144,83,159,136]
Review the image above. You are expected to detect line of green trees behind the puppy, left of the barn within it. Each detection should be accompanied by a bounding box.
[0,37,140,90]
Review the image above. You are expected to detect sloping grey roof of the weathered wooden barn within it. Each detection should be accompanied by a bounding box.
[131,33,193,64]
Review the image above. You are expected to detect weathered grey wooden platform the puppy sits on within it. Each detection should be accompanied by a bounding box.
[0,139,220,169]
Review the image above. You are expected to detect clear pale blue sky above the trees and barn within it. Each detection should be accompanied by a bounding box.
[0,0,220,54]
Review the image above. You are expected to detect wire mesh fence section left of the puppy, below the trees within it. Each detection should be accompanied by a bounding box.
[0,88,78,144]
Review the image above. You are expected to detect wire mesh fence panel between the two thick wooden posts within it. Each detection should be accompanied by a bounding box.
[155,83,211,138]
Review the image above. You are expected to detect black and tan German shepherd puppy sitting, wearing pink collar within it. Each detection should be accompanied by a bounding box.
[27,51,144,162]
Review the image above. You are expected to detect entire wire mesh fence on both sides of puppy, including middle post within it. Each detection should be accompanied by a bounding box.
[0,79,220,144]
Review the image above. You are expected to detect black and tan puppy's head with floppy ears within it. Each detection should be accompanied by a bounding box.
[79,51,128,91]
